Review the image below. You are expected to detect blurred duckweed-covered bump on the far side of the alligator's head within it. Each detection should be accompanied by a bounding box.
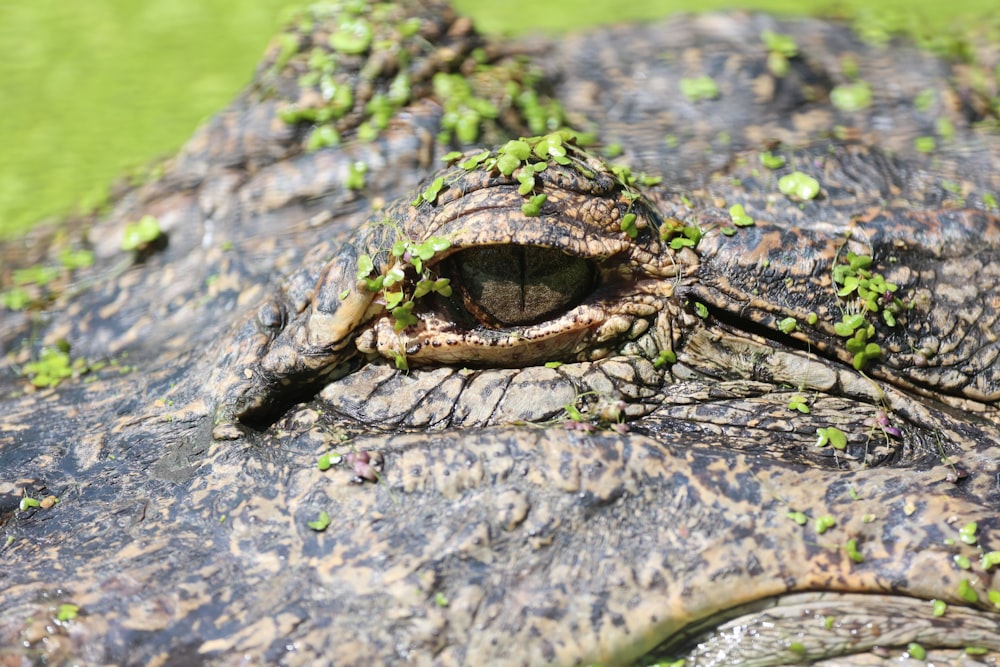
[270,0,566,157]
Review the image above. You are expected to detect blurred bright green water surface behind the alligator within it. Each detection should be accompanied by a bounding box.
[0,0,996,238]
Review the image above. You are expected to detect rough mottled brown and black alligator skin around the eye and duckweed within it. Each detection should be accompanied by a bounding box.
[0,3,1000,665]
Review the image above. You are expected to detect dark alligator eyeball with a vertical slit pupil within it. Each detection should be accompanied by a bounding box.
[449,245,597,326]
